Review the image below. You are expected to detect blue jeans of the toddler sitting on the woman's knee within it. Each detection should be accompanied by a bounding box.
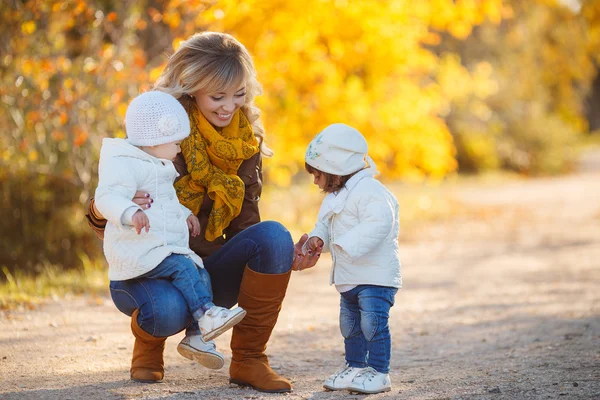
[139,254,214,321]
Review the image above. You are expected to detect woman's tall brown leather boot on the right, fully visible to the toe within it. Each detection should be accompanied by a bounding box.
[229,267,292,393]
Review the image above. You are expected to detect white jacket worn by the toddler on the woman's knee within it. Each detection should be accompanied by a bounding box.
[94,139,203,281]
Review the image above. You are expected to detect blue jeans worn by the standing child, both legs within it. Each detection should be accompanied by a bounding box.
[340,285,398,374]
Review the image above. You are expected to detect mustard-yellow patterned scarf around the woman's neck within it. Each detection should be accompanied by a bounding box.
[175,101,259,241]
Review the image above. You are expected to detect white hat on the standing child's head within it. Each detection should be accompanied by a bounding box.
[304,124,369,176]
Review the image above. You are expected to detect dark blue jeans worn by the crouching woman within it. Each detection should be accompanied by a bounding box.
[110,221,294,337]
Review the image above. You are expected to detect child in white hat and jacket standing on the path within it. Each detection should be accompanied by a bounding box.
[305,124,402,393]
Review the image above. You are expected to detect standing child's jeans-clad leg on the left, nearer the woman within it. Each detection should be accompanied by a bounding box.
[340,288,367,368]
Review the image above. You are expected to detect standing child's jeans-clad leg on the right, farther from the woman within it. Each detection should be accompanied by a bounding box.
[358,285,398,374]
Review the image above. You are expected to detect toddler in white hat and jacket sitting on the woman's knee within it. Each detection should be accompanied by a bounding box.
[95,91,246,368]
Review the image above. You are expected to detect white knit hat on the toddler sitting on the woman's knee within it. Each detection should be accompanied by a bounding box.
[125,90,190,146]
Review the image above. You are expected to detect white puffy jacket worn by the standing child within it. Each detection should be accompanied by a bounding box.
[309,160,402,288]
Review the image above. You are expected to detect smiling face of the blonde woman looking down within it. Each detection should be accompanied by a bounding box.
[194,81,246,128]
